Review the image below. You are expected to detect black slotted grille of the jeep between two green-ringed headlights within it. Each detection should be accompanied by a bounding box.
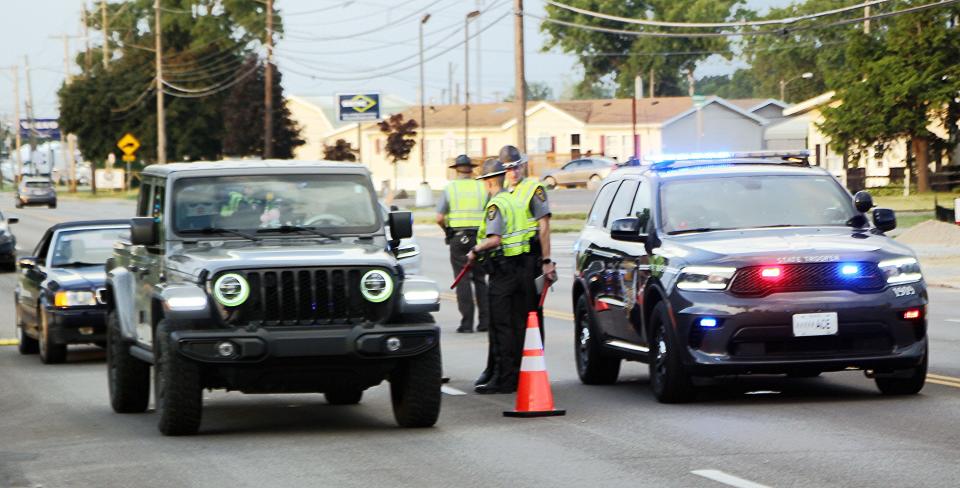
[228,267,392,326]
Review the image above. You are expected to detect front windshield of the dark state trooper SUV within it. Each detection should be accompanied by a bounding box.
[660,175,857,234]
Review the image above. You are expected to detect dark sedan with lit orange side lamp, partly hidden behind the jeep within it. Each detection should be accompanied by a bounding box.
[14,220,130,364]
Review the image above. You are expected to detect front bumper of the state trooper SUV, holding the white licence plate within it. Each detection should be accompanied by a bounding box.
[671,282,927,376]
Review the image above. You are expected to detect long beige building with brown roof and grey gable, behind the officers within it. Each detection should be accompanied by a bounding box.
[298,97,783,190]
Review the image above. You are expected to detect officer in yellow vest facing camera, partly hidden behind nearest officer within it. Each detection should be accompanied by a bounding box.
[499,146,557,337]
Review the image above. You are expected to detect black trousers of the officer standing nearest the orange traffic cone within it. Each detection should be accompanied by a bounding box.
[487,256,536,387]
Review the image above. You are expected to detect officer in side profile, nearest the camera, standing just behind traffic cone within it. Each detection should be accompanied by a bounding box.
[467,158,531,394]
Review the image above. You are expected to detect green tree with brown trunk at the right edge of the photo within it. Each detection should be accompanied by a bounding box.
[820,7,960,191]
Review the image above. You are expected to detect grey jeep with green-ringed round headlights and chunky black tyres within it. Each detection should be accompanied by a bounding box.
[107,161,441,435]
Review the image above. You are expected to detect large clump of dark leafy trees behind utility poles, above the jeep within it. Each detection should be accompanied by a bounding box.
[59,0,296,162]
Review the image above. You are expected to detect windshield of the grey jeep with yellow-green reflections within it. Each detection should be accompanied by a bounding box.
[172,174,380,237]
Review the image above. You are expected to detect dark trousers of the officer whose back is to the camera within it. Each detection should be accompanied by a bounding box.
[449,230,490,329]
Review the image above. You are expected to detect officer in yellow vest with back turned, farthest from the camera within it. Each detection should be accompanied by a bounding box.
[437,154,490,333]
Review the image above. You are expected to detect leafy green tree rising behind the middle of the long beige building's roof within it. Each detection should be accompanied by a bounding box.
[540,0,745,97]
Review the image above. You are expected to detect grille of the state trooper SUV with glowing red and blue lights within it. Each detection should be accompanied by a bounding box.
[730,262,886,296]
